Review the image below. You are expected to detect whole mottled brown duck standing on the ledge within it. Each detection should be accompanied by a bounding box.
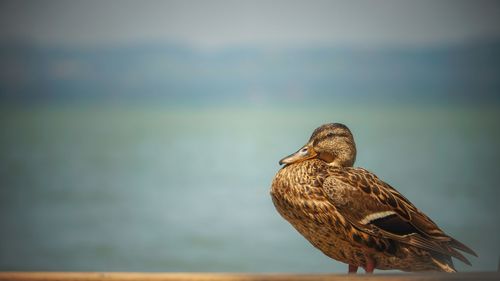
[270,123,477,273]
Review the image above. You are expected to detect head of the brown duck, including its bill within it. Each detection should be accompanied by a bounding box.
[279,123,356,167]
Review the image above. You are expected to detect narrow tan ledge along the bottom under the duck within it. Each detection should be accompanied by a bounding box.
[0,272,500,281]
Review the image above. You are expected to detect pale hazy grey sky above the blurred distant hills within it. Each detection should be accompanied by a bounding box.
[0,0,500,48]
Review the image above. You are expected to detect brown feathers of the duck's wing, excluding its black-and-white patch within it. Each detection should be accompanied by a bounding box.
[323,165,470,264]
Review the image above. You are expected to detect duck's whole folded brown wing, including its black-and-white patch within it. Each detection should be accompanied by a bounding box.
[323,168,476,264]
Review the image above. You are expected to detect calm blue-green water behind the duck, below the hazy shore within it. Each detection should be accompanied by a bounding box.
[0,103,500,272]
